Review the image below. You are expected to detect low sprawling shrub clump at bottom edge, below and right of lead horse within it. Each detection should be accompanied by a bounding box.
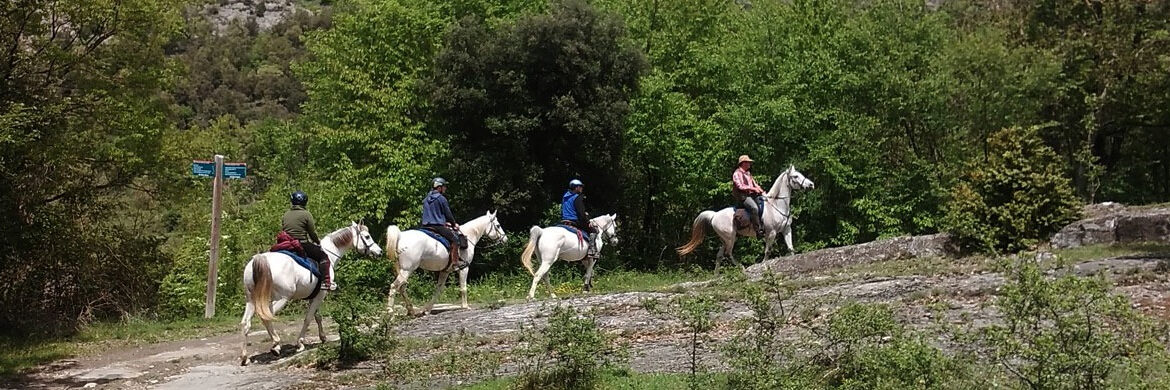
[727,271,965,389]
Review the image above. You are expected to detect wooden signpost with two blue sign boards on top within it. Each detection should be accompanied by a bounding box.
[191,155,248,319]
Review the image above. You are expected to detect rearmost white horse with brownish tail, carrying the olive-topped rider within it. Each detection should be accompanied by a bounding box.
[240,223,381,365]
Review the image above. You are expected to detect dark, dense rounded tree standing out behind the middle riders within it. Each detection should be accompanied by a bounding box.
[425,0,645,225]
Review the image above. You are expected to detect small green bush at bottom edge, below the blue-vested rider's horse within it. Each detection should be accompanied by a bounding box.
[517,306,625,389]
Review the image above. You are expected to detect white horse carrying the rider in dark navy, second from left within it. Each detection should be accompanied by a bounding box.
[386,212,508,315]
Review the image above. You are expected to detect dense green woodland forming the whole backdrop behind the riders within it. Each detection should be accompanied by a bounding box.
[0,0,1170,329]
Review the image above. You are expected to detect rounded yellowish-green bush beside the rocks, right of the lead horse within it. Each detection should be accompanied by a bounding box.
[947,126,1080,252]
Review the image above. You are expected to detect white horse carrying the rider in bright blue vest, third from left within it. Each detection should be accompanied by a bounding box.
[519,214,618,300]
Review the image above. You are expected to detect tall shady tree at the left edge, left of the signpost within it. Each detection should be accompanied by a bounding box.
[0,0,179,333]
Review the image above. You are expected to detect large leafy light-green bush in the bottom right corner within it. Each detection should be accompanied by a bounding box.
[973,256,1170,389]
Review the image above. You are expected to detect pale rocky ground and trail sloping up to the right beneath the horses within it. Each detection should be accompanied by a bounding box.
[9,205,1170,389]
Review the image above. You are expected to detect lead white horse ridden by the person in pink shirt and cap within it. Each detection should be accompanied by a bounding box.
[677,166,814,271]
